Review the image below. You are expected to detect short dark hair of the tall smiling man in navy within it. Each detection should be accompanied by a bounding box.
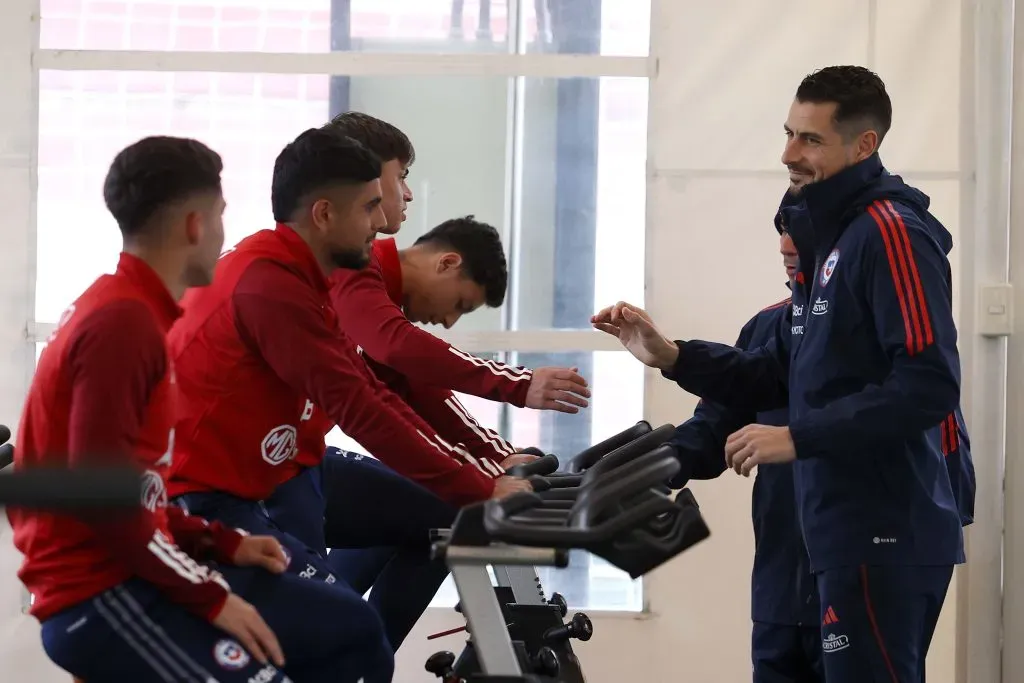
[797,67,893,144]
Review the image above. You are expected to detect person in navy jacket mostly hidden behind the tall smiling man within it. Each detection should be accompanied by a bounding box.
[672,232,975,683]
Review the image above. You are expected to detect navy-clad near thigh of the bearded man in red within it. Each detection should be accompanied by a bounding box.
[174,494,337,584]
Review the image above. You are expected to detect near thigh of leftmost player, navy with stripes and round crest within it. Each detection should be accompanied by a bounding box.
[42,581,291,683]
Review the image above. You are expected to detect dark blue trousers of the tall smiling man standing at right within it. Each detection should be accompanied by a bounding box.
[817,566,953,683]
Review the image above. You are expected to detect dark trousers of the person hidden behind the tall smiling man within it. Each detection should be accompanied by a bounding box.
[751,622,825,683]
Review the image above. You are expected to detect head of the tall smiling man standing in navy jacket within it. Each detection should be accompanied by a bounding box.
[782,67,892,194]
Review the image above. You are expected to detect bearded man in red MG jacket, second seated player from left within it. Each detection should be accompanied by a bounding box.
[163,129,529,614]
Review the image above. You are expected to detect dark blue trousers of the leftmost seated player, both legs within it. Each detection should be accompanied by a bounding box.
[42,567,394,683]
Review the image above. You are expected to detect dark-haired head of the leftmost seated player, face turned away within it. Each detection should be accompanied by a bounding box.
[103,135,225,288]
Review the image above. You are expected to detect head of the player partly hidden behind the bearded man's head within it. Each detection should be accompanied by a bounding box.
[325,112,416,234]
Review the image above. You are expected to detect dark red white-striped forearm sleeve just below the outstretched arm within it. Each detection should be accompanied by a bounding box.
[408,384,515,476]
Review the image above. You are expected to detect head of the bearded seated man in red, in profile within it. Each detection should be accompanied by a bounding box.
[270,128,386,272]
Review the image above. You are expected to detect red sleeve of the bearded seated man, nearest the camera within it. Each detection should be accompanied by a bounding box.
[232,260,494,505]
